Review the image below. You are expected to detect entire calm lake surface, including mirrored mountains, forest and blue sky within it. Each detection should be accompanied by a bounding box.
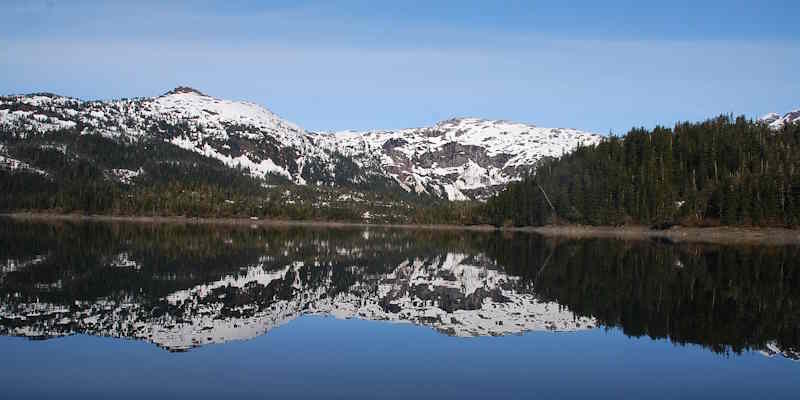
[0,220,800,399]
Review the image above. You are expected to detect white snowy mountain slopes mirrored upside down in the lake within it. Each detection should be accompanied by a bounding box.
[0,253,597,351]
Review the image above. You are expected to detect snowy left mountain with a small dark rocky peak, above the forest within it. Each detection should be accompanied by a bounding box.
[0,87,328,184]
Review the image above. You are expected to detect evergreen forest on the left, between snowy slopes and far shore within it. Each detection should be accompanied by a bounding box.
[0,129,441,223]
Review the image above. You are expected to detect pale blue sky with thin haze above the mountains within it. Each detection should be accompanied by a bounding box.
[0,0,800,134]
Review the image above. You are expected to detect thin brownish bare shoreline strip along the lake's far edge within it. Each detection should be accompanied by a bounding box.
[0,212,800,246]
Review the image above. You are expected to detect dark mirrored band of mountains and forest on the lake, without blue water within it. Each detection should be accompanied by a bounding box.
[0,220,800,359]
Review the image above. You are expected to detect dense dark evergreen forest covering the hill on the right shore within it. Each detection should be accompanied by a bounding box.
[485,116,800,227]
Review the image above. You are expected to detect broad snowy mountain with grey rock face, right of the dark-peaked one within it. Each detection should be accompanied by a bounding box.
[315,118,601,200]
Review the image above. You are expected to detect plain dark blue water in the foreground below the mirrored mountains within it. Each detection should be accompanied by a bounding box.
[0,317,800,399]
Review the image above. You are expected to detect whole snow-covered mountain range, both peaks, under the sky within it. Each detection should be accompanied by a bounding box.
[0,87,601,200]
